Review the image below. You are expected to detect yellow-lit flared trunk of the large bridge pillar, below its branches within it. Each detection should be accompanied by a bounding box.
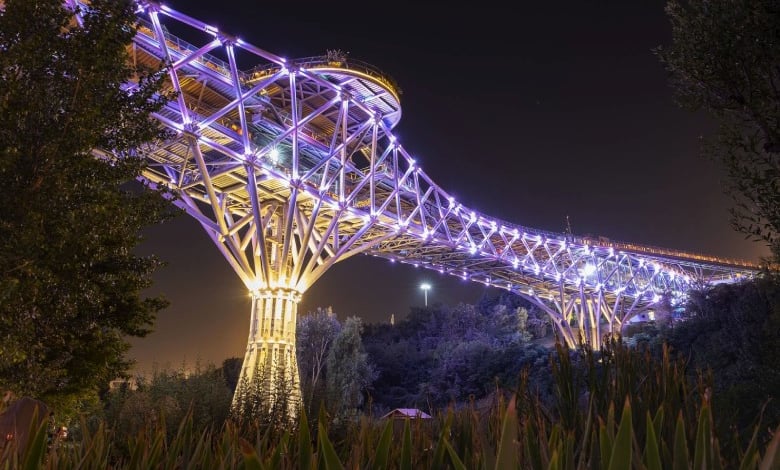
[233,289,301,421]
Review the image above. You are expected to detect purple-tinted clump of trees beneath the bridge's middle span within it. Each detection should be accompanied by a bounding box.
[363,295,549,412]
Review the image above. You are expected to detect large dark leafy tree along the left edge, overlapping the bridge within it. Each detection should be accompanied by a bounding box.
[0,0,173,410]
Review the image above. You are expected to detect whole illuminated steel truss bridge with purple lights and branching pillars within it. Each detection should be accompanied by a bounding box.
[70,0,759,414]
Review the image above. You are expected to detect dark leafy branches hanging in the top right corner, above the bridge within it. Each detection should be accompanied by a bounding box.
[655,0,780,258]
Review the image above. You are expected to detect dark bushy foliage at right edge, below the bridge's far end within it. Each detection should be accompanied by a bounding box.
[667,276,780,438]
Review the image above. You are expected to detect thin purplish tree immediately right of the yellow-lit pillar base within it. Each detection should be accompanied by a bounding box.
[295,308,341,416]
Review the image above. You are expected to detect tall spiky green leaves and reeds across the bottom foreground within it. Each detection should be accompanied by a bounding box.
[0,344,780,470]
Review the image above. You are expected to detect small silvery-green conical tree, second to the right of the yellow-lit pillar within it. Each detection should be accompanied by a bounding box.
[326,317,377,423]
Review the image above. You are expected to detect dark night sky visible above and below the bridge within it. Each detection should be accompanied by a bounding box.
[131,0,765,371]
